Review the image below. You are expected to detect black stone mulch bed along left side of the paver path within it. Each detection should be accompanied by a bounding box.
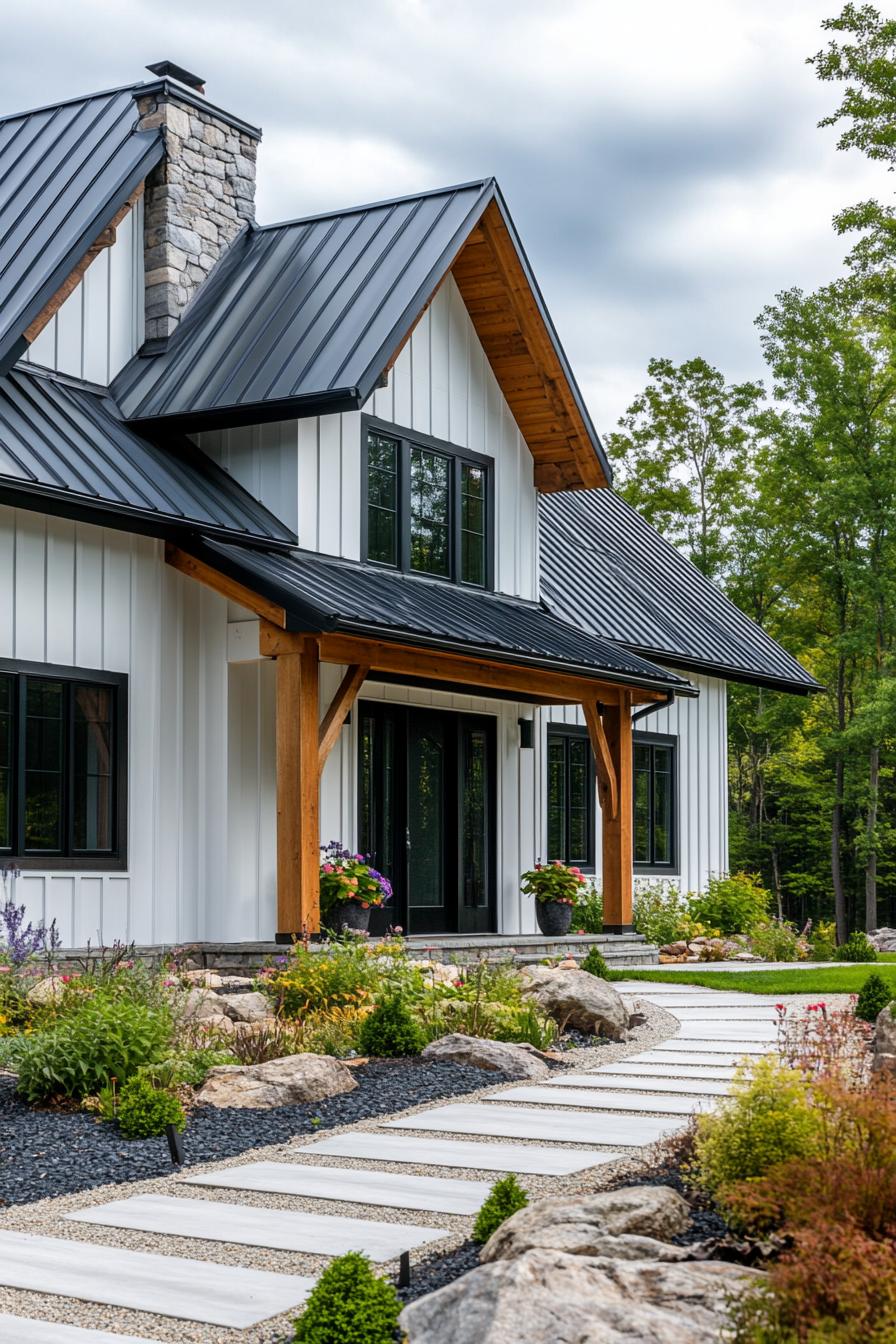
[0,1059,496,1204]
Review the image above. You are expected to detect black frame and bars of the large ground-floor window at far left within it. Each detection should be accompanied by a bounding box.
[0,659,128,872]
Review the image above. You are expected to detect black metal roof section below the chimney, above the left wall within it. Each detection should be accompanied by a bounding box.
[0,368,296,547]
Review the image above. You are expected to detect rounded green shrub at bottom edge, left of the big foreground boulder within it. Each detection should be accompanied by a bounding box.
[293,1251,402,1344]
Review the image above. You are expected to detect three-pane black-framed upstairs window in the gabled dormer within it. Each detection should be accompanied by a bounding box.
[361,415,494,587]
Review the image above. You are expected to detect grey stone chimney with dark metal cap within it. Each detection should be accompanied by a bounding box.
[137,79,261,345]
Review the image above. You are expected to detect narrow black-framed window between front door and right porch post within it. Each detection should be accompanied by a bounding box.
[547,723,595,871]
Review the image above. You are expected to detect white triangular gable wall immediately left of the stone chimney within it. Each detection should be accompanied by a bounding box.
[24,198,144,386]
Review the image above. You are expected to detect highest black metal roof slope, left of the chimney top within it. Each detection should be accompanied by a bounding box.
[0,86,164,374]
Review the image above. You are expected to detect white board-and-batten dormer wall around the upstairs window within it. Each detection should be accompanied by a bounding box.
[197,276,539,599]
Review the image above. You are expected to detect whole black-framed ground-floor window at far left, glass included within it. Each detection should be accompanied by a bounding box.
[0,659,128,867]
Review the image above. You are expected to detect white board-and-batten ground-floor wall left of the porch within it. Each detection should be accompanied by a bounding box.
[0,507,236,946]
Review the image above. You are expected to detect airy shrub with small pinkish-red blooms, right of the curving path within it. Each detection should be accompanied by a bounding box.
[775,996,872,1087]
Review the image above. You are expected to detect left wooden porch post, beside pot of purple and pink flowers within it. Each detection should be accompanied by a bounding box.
[277,640,321,942]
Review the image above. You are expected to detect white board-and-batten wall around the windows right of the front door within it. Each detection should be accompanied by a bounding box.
[548,673,728,891]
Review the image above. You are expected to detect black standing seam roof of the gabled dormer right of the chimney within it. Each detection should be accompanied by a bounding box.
[108,179,610,478]
